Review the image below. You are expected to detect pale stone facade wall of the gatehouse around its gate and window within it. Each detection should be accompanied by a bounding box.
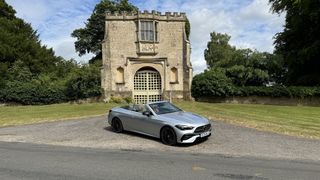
[101,11,192,102]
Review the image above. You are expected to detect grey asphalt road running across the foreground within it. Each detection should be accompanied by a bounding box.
[0,142,320,180]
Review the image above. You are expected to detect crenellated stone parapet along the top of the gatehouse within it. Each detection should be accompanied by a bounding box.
[106,10,187,21]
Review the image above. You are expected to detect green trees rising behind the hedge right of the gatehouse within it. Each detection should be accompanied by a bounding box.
[204,32,285,86]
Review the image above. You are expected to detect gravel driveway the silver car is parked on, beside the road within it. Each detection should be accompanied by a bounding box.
[0,116,320,161]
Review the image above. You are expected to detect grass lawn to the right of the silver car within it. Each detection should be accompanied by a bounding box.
[175,102,320,139]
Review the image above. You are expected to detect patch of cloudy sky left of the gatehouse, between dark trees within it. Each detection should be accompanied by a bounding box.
[8,0,99,62]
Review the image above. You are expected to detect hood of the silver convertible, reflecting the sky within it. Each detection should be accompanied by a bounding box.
[159,111,209,125]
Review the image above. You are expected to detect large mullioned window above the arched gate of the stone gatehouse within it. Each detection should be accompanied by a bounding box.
[139,21,158,42]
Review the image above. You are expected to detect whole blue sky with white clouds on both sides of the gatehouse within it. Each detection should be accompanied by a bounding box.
[6,0,284,74]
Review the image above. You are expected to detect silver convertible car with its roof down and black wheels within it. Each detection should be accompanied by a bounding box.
[108,101,211,145]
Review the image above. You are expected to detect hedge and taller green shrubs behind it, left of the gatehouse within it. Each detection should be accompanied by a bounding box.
[0,61,101,104]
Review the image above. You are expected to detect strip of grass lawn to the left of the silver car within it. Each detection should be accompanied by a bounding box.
[0,103,117,127]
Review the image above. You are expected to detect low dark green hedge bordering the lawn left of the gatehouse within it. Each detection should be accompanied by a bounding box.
[0,81,101,105]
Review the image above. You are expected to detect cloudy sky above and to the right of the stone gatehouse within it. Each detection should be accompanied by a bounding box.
[139,0,284,74]
